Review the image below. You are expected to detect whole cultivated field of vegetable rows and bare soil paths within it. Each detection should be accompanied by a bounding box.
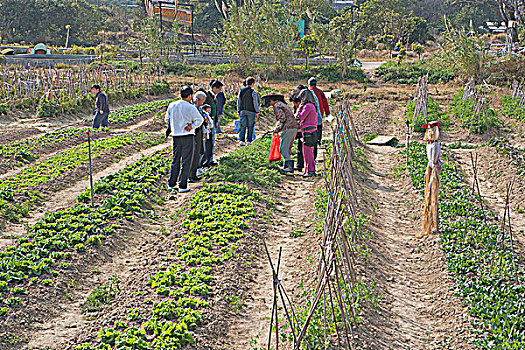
[0,65,525,350]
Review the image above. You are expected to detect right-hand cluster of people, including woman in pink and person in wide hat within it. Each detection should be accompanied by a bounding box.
[263,78,330,177]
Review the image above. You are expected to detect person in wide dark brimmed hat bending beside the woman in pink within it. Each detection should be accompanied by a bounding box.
[263,94,299,174]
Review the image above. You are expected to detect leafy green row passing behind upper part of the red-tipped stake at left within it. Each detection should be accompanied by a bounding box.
[0,133,161,222]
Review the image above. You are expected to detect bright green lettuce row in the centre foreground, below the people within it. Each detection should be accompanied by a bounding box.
[78,183,260,350]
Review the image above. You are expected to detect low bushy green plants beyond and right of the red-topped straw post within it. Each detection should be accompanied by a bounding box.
[450,93,501,134]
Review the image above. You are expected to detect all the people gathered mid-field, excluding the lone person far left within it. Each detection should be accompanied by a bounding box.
[166,77,330,192]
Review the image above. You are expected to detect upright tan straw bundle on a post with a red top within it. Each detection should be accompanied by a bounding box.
[416,121,441,238]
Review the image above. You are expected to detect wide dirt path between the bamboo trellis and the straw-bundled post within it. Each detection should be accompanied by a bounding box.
[358,146,470,350]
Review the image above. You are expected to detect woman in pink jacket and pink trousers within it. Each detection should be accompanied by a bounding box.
[294,90,317,177]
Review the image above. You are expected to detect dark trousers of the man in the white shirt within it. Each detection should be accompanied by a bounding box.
[168,135,195,188]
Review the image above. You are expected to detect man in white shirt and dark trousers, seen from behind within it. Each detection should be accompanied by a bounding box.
[166,86,204,193]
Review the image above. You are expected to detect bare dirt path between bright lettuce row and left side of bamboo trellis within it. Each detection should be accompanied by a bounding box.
[221,177,321,350]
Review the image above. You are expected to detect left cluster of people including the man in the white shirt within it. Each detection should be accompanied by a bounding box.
[166,80,226,193]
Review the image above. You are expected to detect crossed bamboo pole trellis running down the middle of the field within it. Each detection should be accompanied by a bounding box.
[267,102,361,350]
